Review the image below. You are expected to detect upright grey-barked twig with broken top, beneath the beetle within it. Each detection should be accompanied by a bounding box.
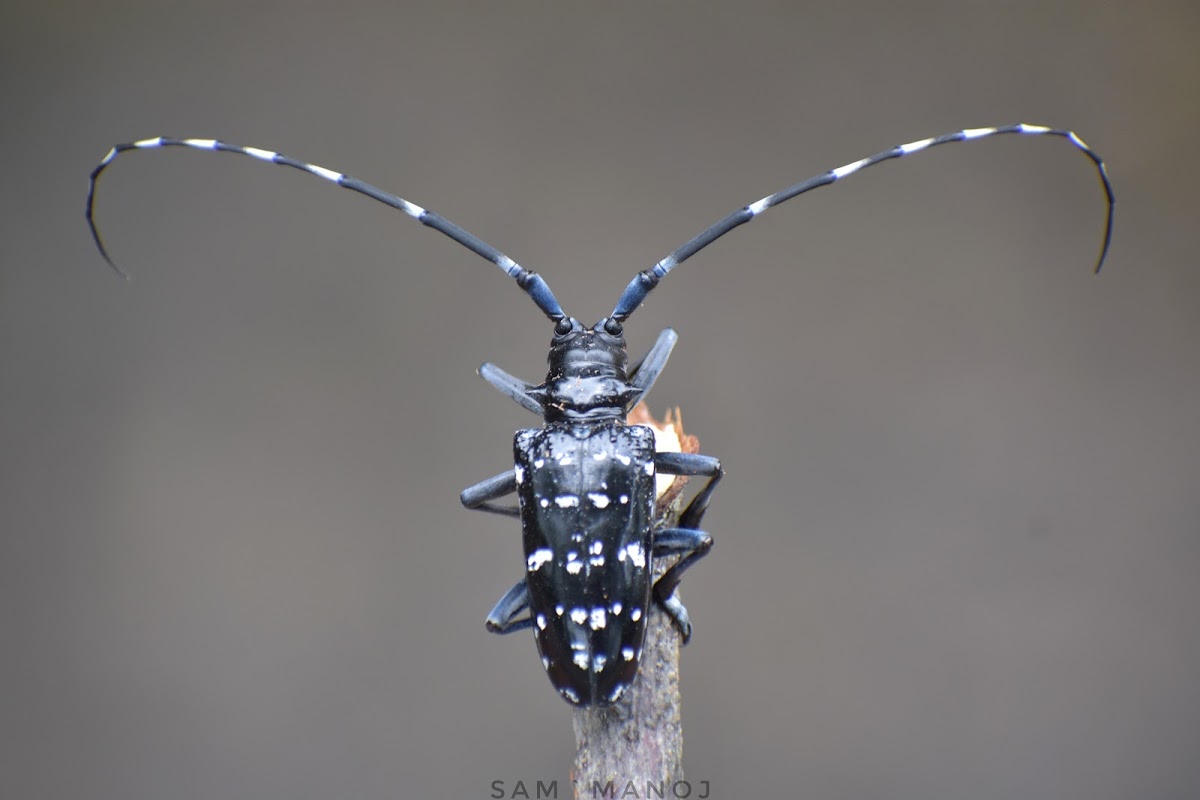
[571,405,700,799]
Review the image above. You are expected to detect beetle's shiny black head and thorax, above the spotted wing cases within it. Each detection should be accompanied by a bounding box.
[534,319,636,422]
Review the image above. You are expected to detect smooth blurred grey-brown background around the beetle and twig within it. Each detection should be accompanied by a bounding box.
[0,0,1200,800]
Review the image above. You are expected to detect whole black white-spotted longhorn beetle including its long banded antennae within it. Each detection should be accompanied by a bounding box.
[86,124,1115,706]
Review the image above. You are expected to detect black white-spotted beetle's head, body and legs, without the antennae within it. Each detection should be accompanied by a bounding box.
[462,317,721,705]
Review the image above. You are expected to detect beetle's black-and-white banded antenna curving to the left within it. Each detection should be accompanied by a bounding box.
[88,137,565,321]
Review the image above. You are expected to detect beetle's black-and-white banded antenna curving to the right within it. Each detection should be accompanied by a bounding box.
[611,124,1115,323]
